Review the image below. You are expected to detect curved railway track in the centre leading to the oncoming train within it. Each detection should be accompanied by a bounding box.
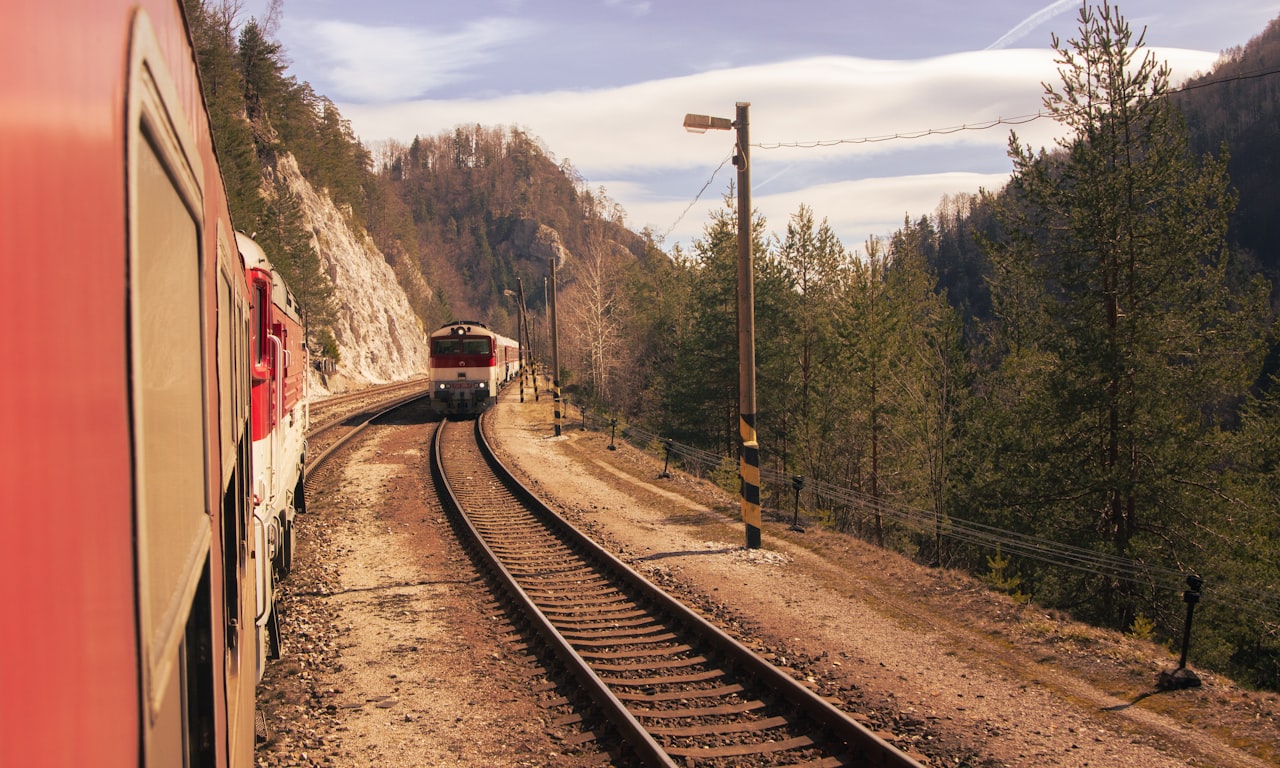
[431,417,919,768]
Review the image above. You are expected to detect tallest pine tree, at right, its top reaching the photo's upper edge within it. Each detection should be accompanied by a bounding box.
[992,4,1265,626]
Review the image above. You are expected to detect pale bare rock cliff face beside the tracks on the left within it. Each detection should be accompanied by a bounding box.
[276,155,428,392]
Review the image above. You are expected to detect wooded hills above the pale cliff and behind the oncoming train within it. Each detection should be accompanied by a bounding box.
[186,0,650,356]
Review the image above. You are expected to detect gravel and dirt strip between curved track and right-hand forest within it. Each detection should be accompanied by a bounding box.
[494,398,1280,768]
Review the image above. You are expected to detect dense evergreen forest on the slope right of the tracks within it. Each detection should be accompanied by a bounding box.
[591,6,1280,689]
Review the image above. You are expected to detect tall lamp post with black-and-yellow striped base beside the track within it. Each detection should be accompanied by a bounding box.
[685,101,760,549]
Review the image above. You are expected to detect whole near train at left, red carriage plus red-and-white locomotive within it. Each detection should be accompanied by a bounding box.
[0,0,306,768]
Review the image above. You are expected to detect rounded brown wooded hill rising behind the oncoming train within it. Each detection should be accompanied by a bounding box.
[370,125,646,337]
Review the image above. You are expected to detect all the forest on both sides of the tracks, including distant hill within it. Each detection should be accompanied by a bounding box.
[187,0,1280,690]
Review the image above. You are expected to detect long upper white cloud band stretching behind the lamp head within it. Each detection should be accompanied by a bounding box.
[343,50,1070,167]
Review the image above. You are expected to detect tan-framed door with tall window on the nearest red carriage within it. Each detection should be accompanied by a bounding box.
[125,10,218,767]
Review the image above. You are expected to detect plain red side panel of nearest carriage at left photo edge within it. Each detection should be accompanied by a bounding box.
[0,3,138,765]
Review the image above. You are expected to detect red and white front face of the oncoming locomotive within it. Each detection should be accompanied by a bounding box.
[431,326,498,413]
